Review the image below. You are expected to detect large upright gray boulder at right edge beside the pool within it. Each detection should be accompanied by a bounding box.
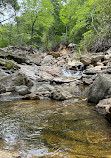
[88,74,111,103]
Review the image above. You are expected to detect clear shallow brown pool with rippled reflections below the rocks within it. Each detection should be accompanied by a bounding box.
[0,98,111,158]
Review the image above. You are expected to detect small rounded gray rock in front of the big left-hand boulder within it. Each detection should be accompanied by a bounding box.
[15,85,30,95]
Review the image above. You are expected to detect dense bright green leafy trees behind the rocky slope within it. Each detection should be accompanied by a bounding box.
[0,0,111,50]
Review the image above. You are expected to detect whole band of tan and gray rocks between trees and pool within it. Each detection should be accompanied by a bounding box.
[0,45,111,118]
